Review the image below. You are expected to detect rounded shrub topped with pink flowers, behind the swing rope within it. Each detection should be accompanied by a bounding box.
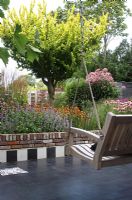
[86,68,119,100]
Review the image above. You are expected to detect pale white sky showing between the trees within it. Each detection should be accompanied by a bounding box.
[0,0,132,77]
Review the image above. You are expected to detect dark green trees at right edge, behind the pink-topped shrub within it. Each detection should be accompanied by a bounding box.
[88,39,132,82]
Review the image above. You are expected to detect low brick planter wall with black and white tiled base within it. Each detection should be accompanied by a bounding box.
[0,132,88,163]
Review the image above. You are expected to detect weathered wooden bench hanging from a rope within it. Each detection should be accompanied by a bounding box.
[69,112,132,169]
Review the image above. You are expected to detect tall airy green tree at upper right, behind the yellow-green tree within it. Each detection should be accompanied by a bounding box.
[64,0,132,64]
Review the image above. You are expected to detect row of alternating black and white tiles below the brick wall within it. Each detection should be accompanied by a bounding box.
[0,146,65,163]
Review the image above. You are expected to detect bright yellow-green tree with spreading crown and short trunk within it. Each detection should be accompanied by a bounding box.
[0,2,107,100]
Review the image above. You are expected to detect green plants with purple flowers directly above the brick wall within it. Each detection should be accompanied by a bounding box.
[0,105,66,134]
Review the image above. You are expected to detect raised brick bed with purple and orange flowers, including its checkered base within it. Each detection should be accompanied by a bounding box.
[0,99,91,162]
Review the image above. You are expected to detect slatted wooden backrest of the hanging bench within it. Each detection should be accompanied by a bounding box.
[96,113,132,157]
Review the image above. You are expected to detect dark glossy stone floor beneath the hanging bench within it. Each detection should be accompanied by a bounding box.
[0,157,132,200]
